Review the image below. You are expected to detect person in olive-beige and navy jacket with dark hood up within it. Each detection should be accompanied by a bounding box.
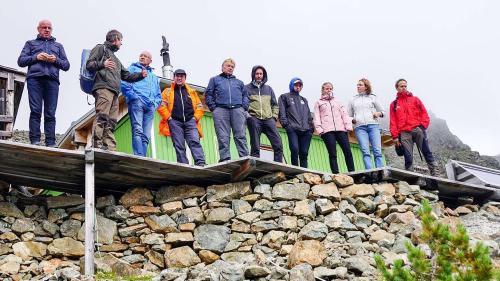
[245,65,283,162]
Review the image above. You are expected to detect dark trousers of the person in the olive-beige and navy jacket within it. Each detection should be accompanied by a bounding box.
[247,116,283,162]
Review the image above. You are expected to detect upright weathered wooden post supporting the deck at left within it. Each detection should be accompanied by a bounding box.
[85,149,95,276]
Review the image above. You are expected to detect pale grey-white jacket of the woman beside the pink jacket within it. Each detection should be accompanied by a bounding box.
[347,93,385,128]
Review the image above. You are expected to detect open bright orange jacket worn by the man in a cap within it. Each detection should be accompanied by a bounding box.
[158,83,205,138]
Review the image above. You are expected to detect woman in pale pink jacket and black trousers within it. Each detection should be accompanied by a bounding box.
[314,82,354,174]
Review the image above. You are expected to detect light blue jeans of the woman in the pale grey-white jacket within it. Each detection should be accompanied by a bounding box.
[354,124,384,169]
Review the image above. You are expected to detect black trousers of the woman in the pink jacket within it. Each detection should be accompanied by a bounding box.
[321,131,354,174]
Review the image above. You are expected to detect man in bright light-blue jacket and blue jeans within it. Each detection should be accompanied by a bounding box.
[121,51,161,156]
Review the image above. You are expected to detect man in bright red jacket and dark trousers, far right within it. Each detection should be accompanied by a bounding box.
[390,79,437,176]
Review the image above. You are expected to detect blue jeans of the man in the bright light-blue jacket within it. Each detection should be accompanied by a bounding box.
[128,98,154,156]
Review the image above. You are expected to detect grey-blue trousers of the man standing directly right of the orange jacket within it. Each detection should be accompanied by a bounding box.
[212,107,248,162]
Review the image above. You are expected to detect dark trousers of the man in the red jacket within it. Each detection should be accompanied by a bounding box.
[400,127,436,170]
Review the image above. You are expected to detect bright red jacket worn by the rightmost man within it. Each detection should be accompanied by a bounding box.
[389,91,430,139]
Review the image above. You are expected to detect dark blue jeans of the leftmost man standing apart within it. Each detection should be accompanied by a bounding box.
[27,77,59,146]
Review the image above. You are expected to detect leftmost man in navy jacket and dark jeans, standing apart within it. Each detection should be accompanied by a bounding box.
[17,20,69,147]
